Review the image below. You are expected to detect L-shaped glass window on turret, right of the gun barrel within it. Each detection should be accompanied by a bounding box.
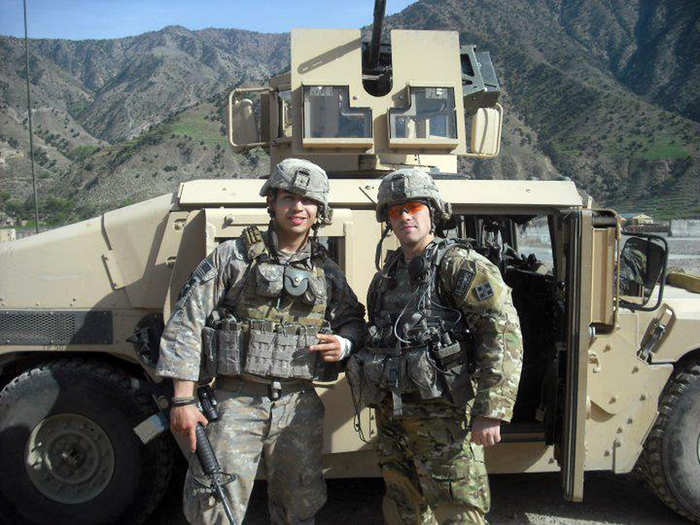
[389,87,457,139]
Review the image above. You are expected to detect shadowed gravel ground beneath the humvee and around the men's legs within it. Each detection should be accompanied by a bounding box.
[148,464,688,525]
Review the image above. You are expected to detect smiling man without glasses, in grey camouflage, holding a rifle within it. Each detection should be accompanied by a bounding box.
[157,159,366,524]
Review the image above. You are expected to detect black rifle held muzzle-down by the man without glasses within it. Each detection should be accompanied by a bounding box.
[134,386,236,525]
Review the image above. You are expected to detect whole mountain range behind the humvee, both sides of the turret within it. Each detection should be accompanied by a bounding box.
[0,0,700,223]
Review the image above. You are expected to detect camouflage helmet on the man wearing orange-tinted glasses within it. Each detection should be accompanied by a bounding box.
[376,168,452,227]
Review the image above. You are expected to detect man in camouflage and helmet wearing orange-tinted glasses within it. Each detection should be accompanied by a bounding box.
[348,169,522,524]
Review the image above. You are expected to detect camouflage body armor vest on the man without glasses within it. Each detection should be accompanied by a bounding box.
[205,227,338,381]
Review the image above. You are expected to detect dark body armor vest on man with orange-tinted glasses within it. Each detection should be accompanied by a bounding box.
[348,239,474,415]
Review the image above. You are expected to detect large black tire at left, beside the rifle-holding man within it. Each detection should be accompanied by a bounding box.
[0,359,174,525]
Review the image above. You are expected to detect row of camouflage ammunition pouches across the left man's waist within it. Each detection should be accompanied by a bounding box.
[202,319,338,382]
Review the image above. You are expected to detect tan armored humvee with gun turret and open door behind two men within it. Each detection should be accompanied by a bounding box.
[0,2,700,524]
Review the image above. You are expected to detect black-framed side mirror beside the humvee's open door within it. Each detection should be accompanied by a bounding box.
[620,232,668,311]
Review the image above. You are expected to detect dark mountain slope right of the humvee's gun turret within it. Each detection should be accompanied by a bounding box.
[388,0,700,217]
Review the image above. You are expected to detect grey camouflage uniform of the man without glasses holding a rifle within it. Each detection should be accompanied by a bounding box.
[157,161,366,524]
